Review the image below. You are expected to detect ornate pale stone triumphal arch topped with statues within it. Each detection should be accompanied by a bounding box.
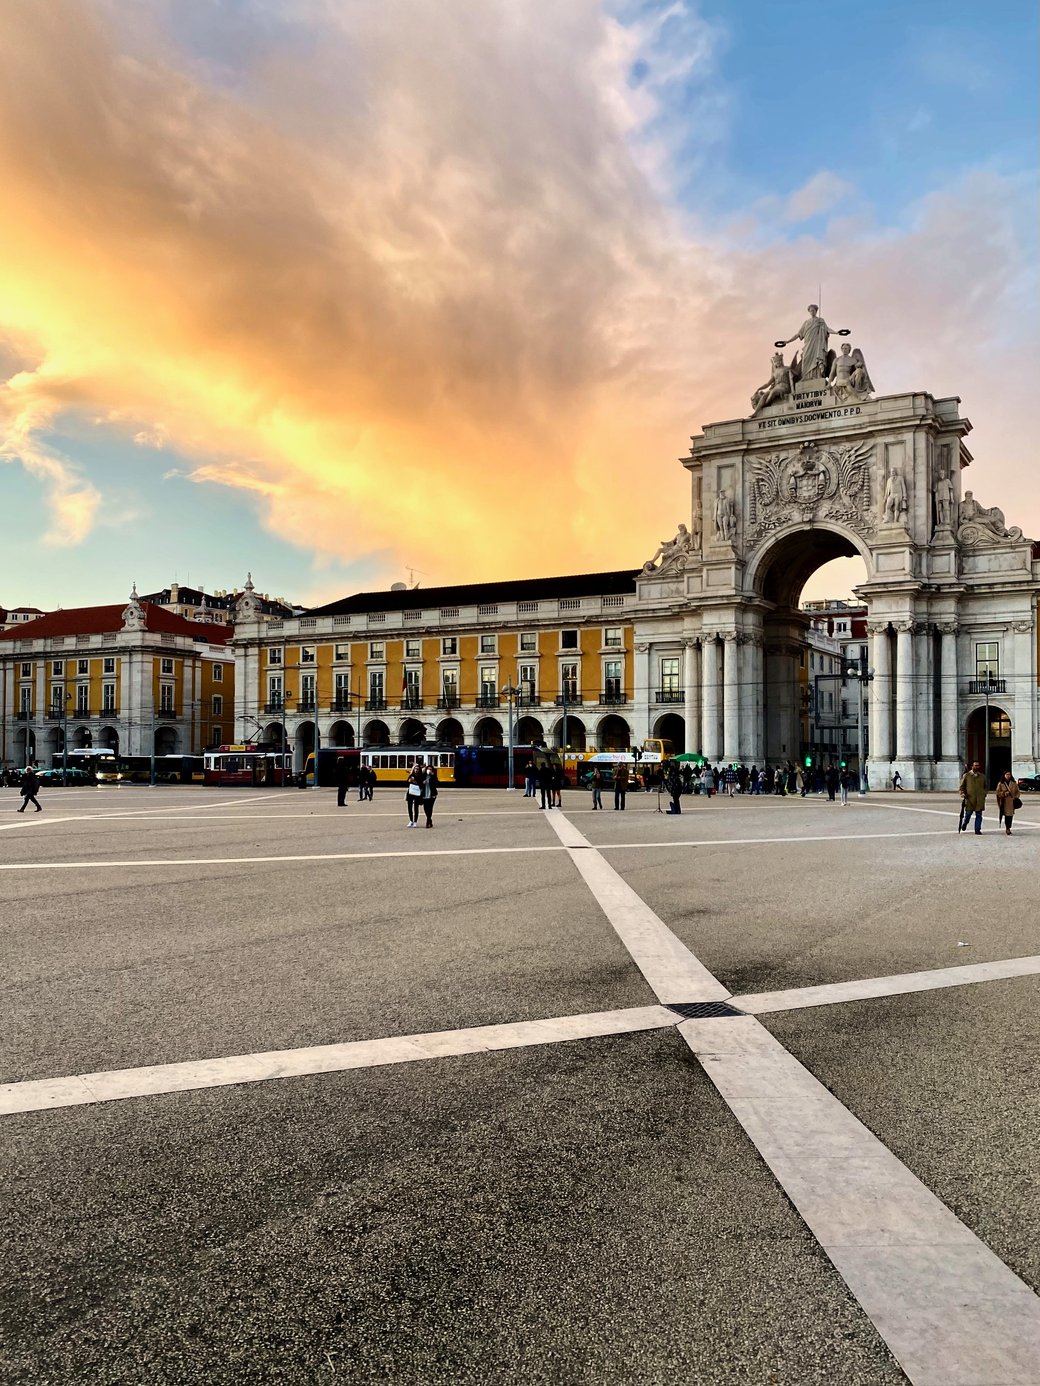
[635,305,1040,789]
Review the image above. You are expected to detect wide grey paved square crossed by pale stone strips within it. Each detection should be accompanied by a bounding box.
[0,787,1040,1386]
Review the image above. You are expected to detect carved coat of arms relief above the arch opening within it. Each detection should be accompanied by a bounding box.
[746,442,875,543]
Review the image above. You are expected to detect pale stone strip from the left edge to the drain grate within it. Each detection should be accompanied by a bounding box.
[0,1006,679,1116]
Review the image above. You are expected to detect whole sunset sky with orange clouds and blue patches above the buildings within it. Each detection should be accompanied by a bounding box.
[0,0,1040,608]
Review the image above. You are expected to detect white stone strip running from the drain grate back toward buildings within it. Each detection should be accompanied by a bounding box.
[545,814,729,1003]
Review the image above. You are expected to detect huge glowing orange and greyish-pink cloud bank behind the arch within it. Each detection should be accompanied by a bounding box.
[0,0,1040,595]
